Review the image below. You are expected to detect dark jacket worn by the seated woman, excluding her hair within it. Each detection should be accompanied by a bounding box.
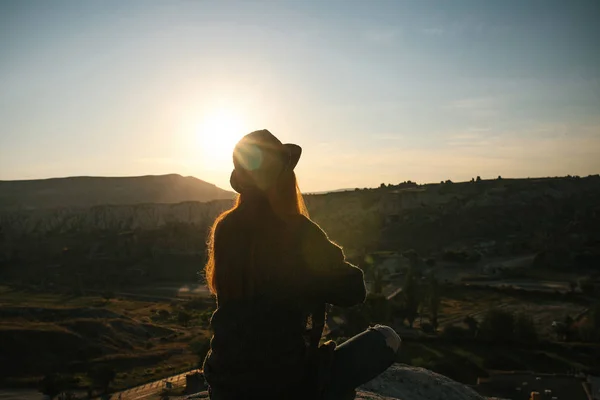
[204,216,366,399]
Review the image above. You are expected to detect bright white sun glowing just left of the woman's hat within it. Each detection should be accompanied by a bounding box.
[198,109,244,169]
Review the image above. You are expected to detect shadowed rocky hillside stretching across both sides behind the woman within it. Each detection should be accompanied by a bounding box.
[0,176,600,288]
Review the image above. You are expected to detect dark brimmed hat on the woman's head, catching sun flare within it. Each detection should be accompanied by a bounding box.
[229,129,302,193]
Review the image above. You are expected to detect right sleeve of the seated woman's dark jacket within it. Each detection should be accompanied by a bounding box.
[301,218,366,307]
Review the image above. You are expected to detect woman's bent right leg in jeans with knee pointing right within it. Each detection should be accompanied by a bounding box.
[323,325,402,400]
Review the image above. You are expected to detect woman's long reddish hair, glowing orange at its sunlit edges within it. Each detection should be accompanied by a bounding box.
[205,171,308,299]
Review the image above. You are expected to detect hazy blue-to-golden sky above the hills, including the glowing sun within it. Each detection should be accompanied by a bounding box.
[0,0,600,191]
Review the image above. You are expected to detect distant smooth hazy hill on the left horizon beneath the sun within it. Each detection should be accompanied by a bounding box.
[0,174,234,210]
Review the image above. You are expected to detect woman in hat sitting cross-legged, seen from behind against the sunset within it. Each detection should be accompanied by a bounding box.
[204,130,400,400]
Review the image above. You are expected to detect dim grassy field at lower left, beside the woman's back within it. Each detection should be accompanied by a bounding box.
[0,287,214,392]
